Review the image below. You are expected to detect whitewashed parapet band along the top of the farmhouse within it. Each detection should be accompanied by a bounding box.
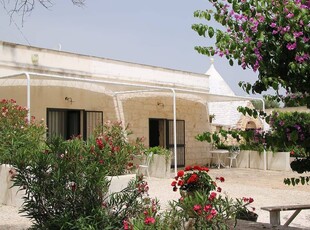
[0,41,209,92]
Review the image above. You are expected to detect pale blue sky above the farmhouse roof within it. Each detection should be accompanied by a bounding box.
[0,0,257,97]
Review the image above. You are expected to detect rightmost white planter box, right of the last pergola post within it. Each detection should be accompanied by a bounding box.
[267,152,291,171]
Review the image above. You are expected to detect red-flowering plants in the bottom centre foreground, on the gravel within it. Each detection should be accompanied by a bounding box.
[170,166,253,229]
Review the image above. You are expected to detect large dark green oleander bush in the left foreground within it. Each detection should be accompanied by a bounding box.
[13,137,151,229]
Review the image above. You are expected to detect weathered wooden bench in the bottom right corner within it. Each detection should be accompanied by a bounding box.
[261,204,310,226]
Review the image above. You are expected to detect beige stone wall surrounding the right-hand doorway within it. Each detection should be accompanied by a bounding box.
[123,97,210,165]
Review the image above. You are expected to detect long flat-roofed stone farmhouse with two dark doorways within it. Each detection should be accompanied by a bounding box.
[0,41,257,168]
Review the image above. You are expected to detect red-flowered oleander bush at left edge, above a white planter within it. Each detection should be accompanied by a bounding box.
[0,99,45,164]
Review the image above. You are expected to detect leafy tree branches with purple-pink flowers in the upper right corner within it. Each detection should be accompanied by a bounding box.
[192,0,310,107]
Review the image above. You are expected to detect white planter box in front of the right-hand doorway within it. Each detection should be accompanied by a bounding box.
[149,154,171,178]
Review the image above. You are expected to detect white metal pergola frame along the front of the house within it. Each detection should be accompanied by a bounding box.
[0,72,267,172]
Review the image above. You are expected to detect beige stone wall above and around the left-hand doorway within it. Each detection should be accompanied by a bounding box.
[0,86,117,130]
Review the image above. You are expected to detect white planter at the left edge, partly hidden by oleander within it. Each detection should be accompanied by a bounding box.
[0,164,25,207]
